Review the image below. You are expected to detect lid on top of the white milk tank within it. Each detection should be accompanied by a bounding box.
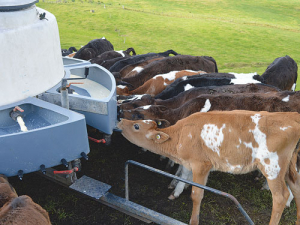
[0,0,39,12]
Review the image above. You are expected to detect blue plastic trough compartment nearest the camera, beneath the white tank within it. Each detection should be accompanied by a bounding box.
[0,98,89,177]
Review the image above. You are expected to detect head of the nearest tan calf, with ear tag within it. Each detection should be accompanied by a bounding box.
[118,119,169,149]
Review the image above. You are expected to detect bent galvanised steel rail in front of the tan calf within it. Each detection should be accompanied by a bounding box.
[125,160,254,225]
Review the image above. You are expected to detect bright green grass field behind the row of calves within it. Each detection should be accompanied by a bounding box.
[37,0,300,77]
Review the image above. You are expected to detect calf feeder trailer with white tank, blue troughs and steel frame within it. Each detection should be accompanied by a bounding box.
[0,0,253,224]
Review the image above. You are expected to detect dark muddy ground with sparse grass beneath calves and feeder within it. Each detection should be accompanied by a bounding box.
[9,127,296,225]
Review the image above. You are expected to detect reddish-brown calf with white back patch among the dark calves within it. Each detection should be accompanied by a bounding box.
[117,70,206,96]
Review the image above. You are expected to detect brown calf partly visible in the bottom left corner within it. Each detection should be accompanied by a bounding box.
[0,175,51,225]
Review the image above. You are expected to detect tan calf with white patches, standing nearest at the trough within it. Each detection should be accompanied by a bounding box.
[118,111,300,225]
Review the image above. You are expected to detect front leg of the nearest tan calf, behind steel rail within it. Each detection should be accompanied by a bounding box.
[190,163,212,225]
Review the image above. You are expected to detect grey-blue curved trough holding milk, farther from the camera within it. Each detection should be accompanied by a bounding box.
[39,63,117,134]
